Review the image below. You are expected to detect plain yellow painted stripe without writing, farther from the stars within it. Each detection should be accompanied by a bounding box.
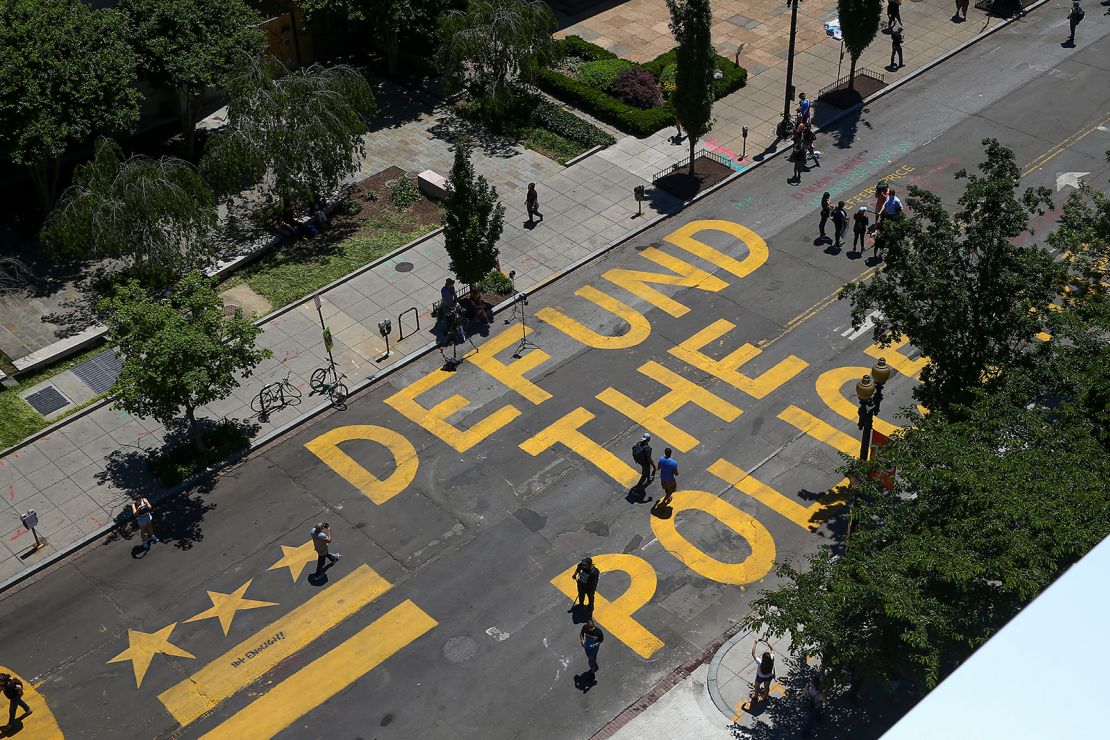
[203,599,438,739]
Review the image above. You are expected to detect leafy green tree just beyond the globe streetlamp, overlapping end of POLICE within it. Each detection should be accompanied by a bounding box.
[840,139,1060,412]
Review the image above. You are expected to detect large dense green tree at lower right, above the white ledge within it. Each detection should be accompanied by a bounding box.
[747,373,1110,689]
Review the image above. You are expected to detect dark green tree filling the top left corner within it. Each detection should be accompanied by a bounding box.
[0,0,140,213]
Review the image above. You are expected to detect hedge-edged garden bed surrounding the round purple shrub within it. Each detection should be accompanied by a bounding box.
[536,36,748,136]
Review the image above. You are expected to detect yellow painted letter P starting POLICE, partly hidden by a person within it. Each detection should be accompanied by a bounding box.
[552,553,663,660]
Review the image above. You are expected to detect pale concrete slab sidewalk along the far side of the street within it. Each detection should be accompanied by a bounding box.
[0,0,1021,582]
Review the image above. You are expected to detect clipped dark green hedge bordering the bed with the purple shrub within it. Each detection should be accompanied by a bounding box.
[536,36,748,138]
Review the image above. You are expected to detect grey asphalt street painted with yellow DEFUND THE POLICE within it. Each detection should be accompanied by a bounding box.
[0,11,1110,739]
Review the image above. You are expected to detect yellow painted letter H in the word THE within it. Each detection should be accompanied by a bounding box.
[597,361,740,453]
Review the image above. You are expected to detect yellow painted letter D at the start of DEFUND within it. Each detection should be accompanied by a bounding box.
[304,424,420,504]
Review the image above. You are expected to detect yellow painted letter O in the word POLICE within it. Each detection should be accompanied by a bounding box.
[652,490,775,586]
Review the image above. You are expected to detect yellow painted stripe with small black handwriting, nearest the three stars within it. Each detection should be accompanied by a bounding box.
[158,565,390,727]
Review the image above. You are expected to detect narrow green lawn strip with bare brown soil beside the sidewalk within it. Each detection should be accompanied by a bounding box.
[220,210,440,308]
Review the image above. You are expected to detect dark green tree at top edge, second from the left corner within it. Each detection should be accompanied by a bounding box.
[119,0,266,158]
